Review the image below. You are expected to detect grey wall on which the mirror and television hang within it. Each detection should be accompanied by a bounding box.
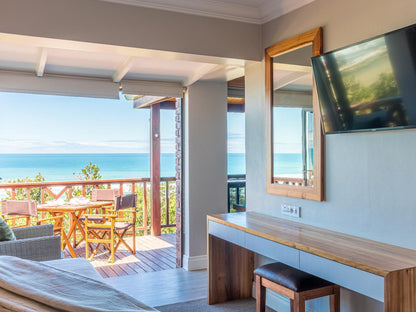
[246,0,416,312]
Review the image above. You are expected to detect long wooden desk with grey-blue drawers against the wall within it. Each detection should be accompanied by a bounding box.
[207,212,416,312]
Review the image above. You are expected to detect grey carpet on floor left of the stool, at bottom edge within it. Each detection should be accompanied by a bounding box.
[156,298,274,312]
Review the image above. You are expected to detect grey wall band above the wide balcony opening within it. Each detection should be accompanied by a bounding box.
[0,0,262,60]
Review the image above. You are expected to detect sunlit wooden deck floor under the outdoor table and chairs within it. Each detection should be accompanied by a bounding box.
[65,234,176,278]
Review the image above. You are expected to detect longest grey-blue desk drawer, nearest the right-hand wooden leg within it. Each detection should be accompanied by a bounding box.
[299,251,384,302]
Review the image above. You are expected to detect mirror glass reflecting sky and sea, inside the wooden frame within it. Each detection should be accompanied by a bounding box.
[272,45,314,187]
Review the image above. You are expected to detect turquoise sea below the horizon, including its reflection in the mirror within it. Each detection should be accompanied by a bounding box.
[0,153,302,182]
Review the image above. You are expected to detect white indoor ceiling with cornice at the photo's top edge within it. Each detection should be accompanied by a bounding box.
[102,0,314,24]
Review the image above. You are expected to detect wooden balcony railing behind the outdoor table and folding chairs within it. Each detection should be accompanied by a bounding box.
[0,177,176,234]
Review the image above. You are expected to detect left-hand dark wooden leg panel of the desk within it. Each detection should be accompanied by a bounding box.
[208,234,254,304]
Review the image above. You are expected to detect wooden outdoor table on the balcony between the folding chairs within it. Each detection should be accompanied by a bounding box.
[38,201,113,258]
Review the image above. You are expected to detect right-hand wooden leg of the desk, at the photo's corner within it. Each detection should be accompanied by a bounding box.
[384,268,416,312]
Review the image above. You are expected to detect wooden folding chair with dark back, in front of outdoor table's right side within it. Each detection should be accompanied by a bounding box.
[84,194,137,263]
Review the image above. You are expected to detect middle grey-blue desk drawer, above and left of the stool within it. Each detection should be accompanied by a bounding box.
[246,233,299,268]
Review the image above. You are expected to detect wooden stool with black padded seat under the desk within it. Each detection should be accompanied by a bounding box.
[254,262,340,312]
